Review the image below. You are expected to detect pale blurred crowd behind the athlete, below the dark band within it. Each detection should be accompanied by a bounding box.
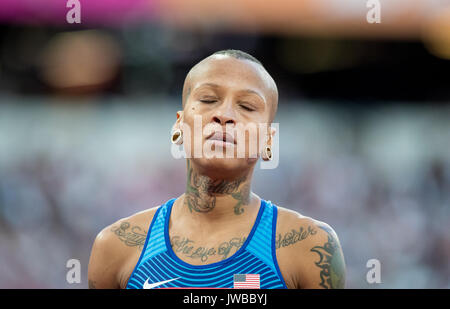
[0,97,450,288]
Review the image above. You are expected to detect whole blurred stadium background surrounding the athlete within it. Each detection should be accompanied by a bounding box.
[0,0,450,288]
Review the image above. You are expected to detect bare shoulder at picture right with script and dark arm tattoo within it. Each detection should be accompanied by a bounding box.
[275,207,345,288]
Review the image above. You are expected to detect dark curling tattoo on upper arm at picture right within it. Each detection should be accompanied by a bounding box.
[311,227,345,289]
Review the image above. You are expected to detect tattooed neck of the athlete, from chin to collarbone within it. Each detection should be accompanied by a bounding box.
[183,160,253,220]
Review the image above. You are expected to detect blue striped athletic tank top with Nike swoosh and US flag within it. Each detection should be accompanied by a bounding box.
[127,198,287,289]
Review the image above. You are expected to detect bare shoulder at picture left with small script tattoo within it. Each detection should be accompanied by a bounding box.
[88,206,159,288]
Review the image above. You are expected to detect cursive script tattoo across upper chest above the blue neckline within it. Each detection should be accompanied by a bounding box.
[170,236,246,262]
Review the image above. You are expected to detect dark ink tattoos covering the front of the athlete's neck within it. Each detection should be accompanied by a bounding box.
[184,160,250,215]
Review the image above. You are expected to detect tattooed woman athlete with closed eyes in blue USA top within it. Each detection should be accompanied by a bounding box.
[88,50,345,289]
